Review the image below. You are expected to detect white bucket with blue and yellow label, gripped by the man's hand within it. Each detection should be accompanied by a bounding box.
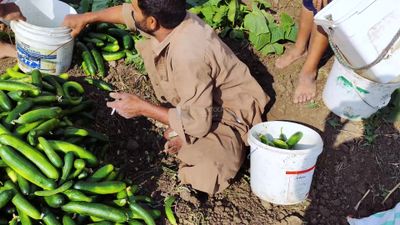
[11,0,76,74]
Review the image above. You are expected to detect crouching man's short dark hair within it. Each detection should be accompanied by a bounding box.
[138,0,186,29]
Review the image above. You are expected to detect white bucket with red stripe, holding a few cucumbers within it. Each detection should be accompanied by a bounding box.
[248,121,323,205]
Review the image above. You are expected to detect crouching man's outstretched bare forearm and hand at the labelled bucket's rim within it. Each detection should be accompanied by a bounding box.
[63,5,125,37]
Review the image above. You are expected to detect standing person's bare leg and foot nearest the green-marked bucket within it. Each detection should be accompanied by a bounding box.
[293,25,328,103]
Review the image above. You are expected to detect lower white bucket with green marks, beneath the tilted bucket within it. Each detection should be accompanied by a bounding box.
[322,59,400,121]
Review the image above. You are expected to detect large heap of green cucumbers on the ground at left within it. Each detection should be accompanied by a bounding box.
[0,66,174,225]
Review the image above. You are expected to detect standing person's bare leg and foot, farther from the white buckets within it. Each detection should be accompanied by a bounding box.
[275,6,314,69]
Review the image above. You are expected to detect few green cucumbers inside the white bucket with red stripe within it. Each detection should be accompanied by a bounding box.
[258,128,303,150]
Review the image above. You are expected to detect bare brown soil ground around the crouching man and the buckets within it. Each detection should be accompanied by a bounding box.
[0,0,400,225]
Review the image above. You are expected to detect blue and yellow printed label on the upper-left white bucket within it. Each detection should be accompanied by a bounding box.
[16,42,57,73]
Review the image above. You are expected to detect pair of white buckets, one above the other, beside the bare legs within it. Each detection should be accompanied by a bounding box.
[314,0,400,120]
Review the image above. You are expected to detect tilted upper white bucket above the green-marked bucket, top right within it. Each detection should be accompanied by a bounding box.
[314,0,400,83]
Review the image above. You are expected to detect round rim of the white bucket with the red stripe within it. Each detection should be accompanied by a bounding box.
[248,120,324,155]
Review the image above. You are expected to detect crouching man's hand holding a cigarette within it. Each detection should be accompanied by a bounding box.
[107,93,149,119]
